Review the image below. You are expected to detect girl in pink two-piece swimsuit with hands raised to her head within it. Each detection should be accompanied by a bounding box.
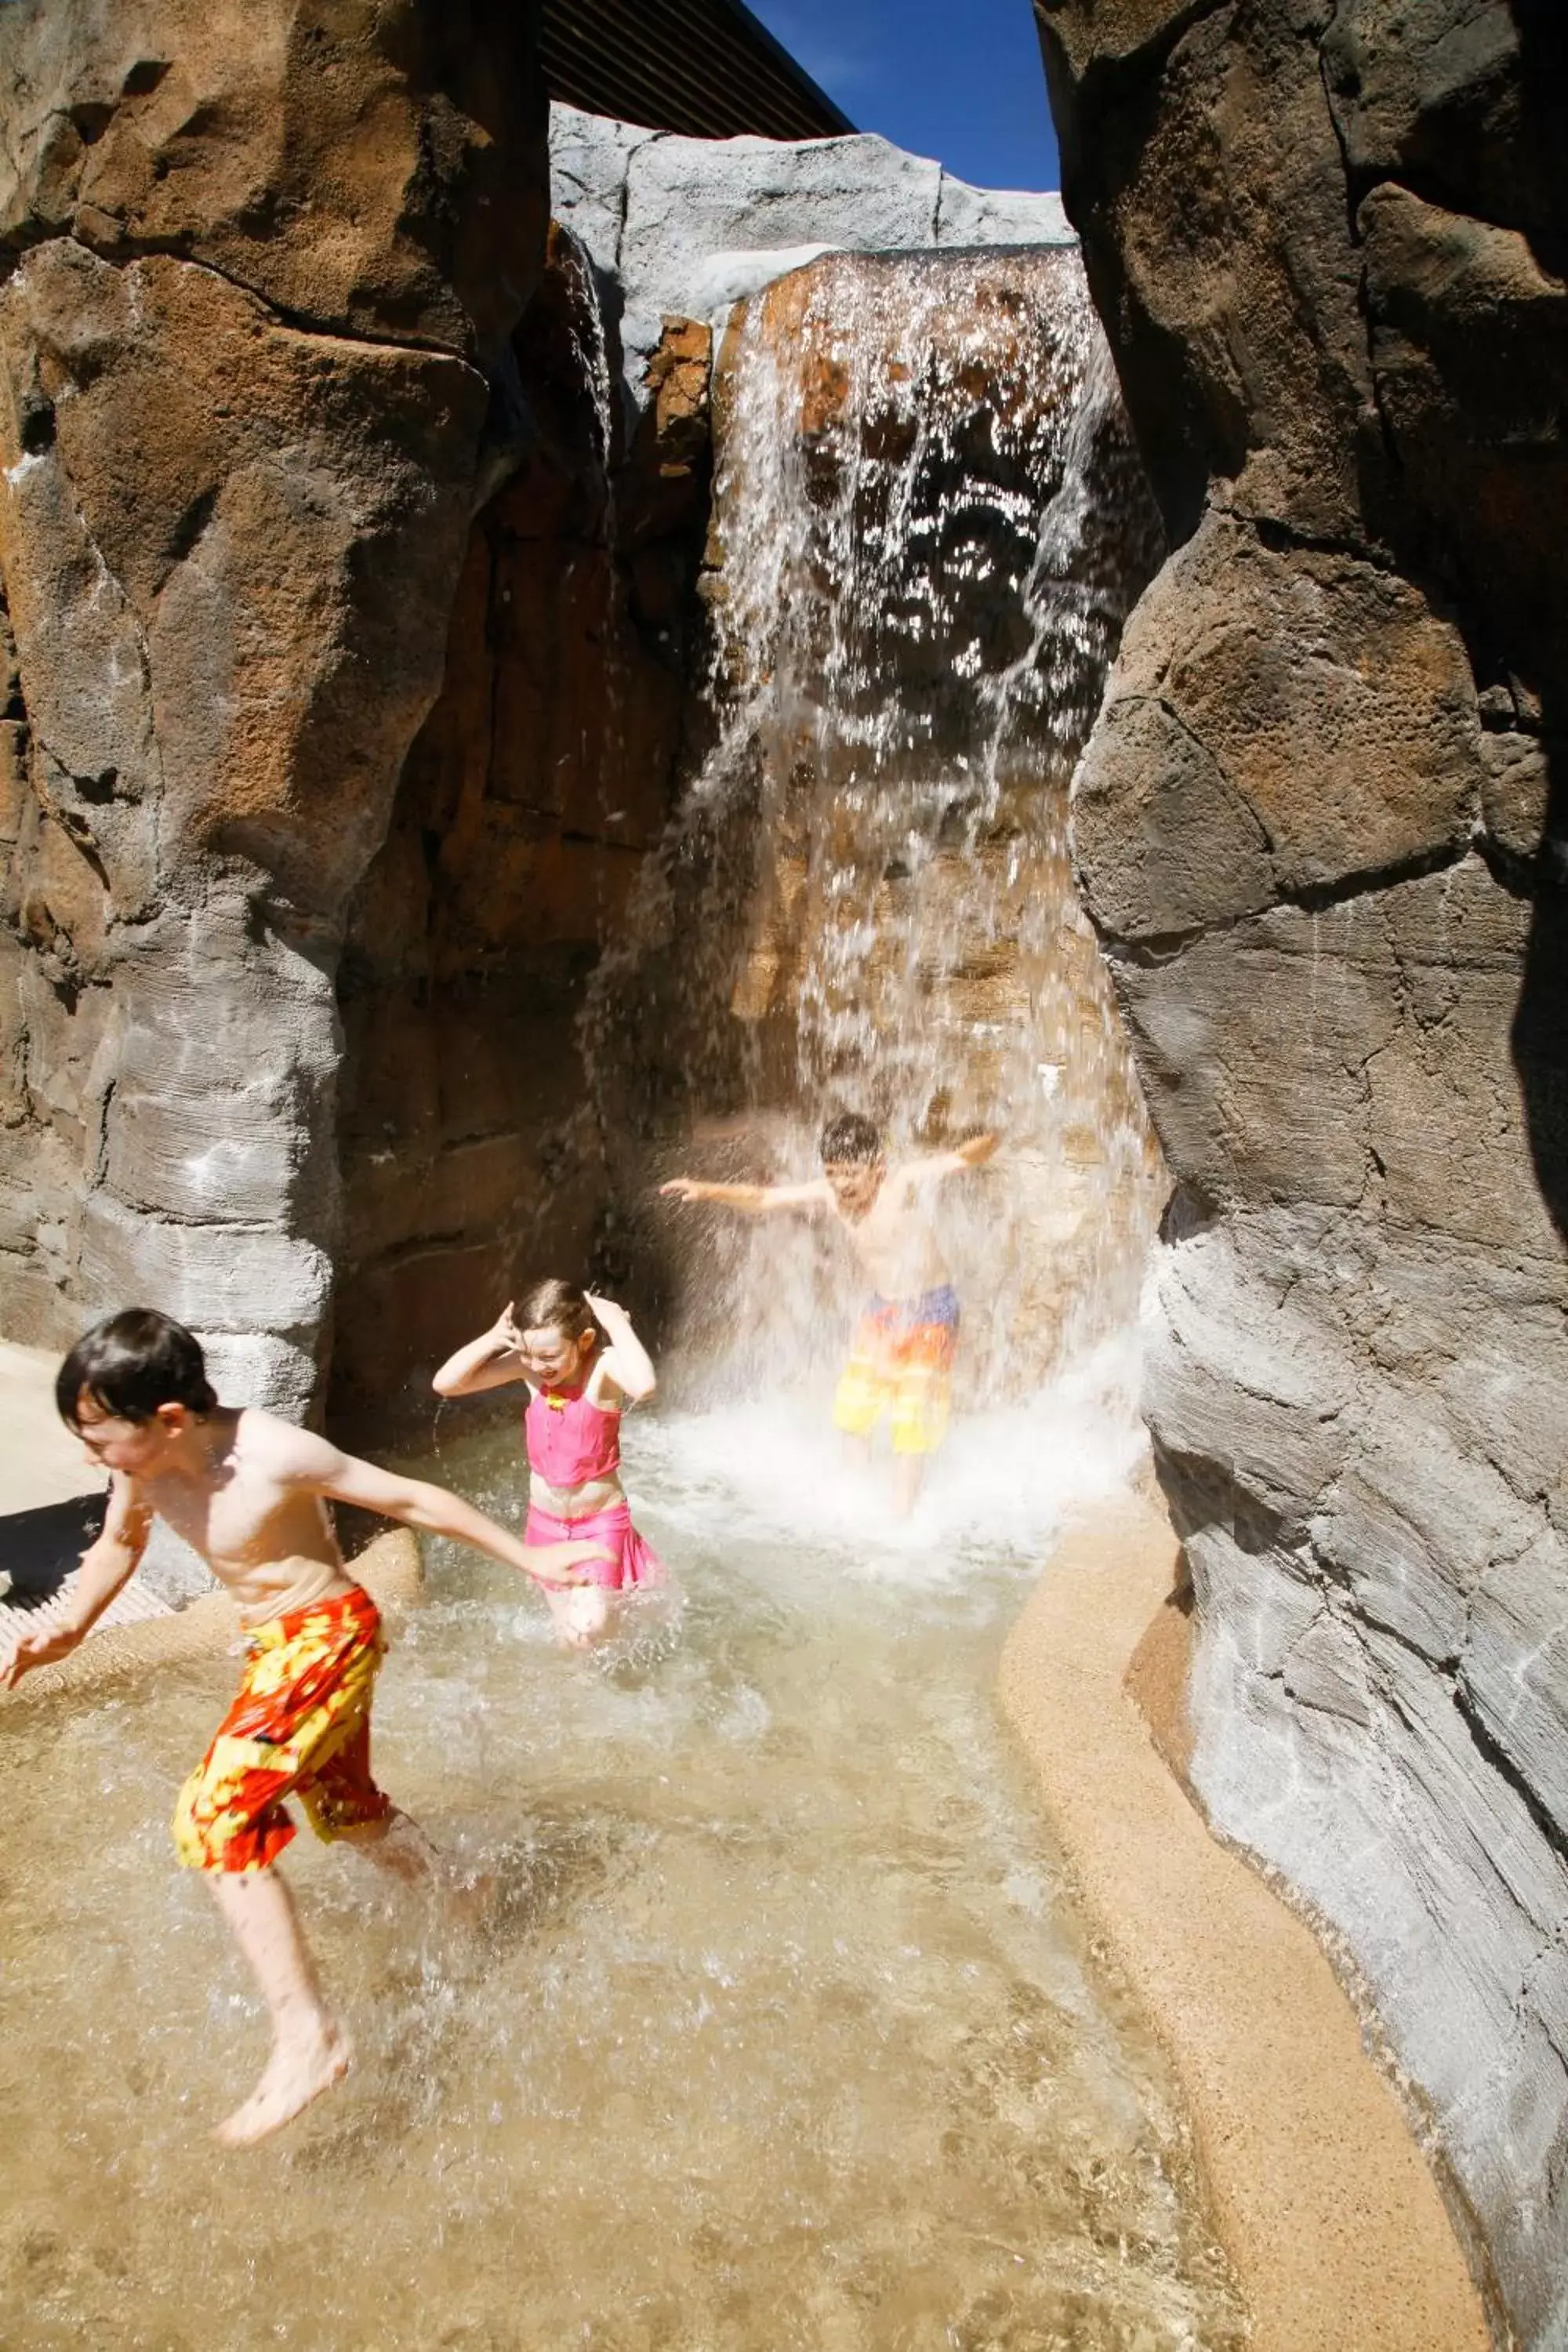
[433,1282,663,1649]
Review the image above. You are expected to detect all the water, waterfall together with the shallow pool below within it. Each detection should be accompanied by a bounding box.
[0,254,1241,2352]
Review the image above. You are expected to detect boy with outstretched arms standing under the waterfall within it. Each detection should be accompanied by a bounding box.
[663,1110,996,1517]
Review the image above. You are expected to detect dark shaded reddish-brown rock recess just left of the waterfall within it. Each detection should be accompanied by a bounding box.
[332,230,710,1421]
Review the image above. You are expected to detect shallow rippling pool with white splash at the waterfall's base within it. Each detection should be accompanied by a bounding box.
[0,1383,1239,2352]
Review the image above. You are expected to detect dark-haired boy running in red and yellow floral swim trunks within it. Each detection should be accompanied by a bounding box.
[0,1308,604,2147]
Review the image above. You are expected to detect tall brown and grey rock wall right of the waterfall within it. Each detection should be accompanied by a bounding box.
[1036,0,1568,2345]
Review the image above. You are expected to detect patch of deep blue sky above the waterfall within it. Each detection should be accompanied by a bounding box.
[748,0,1060,188]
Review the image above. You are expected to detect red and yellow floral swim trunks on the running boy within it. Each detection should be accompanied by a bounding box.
[174,1585,393,1870]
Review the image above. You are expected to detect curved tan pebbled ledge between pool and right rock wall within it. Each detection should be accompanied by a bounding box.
[1001,1494,1490,2352]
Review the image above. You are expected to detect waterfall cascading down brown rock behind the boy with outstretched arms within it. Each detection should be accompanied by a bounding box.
[588,249,1159,1399]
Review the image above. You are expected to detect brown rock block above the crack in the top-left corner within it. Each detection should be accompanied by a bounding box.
[0,0,546,367]
